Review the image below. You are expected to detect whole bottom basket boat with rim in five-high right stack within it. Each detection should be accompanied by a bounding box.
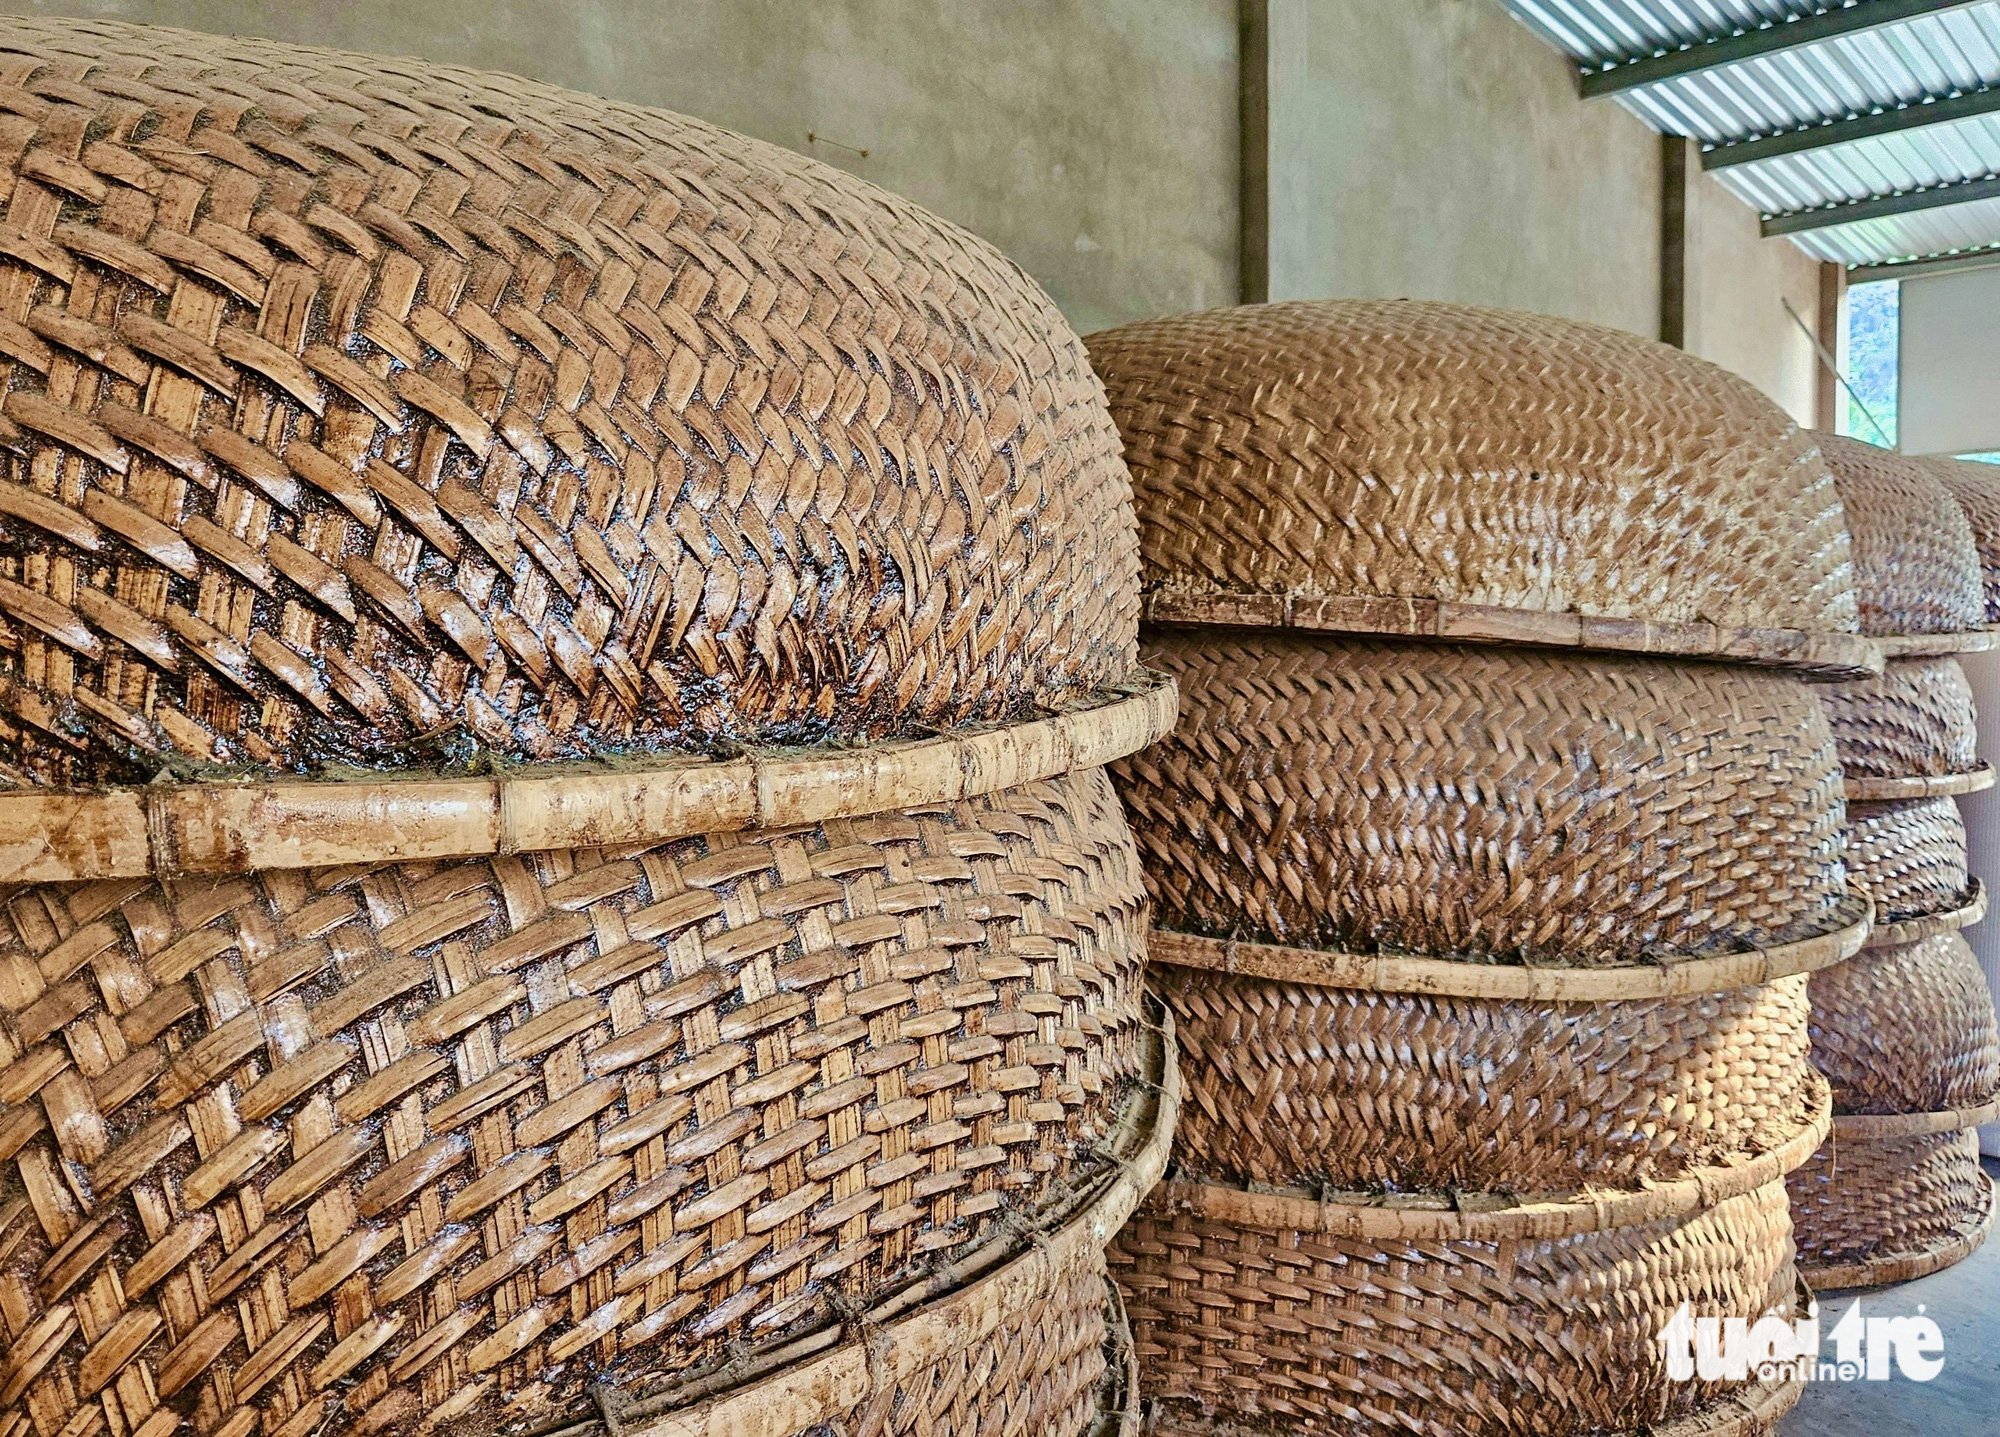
[1786,1105,2000,1291]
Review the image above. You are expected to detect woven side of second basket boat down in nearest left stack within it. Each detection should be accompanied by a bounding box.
[0,771,1144,1437]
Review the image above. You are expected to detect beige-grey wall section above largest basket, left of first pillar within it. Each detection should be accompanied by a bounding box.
[0,0,1238,330]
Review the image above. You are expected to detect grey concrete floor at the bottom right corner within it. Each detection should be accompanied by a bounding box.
[1778,1159,2000,1437]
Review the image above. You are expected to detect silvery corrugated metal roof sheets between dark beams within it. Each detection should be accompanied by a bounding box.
[1502,0,2000,264]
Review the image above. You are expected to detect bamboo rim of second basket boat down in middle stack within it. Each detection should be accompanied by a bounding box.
[1146,899,1874,1003]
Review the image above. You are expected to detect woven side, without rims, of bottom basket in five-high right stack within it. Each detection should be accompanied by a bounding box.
[1786,1127,1992,1283]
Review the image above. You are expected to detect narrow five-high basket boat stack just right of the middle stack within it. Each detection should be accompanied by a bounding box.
[1790,436,2000,1287]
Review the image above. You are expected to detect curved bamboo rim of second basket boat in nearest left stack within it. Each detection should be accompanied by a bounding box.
[616,1011,1180,1437]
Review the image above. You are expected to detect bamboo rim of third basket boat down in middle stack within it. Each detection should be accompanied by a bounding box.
[1148,1073,1834,1243]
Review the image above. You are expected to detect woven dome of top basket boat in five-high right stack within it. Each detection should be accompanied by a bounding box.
[1816,434,1986,636]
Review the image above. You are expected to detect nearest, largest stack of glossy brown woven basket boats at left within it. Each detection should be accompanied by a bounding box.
[0,20,1174,1437]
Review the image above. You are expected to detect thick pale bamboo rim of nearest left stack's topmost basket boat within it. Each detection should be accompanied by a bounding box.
[0,672,1178,883]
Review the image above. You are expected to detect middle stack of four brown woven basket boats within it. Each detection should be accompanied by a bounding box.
[1090,302,1880,1437]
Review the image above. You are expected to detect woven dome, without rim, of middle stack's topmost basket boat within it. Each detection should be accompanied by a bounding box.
[1088,300,1856,632]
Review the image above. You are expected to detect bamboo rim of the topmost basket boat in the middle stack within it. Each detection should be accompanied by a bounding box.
[1142,588,1880,680]
